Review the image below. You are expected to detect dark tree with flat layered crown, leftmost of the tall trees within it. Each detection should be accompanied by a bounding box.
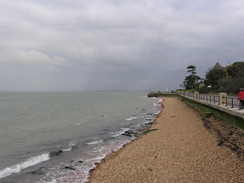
[184,65,201,89]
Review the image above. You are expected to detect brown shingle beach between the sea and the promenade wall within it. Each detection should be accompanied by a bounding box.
[89,98,244,183]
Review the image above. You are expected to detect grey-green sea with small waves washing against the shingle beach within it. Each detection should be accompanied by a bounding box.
[0,91,161,183]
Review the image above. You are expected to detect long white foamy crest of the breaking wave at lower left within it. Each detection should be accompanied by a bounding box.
[0,153,50,179]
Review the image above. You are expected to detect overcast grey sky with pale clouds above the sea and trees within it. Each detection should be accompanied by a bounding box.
[0,0,244,91]
